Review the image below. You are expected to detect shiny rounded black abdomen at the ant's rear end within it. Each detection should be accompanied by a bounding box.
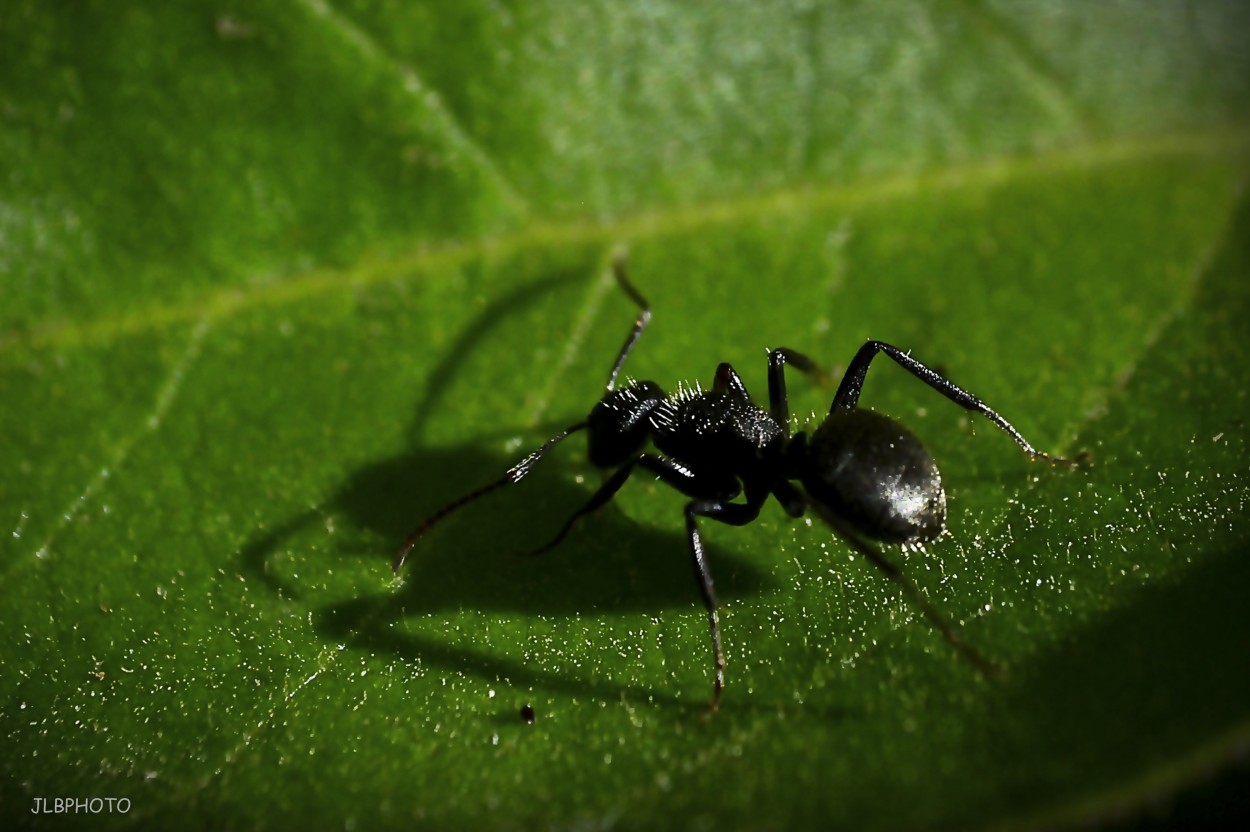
[788,407,946,543]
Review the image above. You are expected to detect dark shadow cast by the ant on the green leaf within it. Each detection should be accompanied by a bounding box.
[241,272,771,708]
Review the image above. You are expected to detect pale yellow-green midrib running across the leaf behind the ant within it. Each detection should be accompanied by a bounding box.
[0,124,1250,354]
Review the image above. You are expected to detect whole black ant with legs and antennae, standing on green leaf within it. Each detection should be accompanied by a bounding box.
[393,257,1069,711]
